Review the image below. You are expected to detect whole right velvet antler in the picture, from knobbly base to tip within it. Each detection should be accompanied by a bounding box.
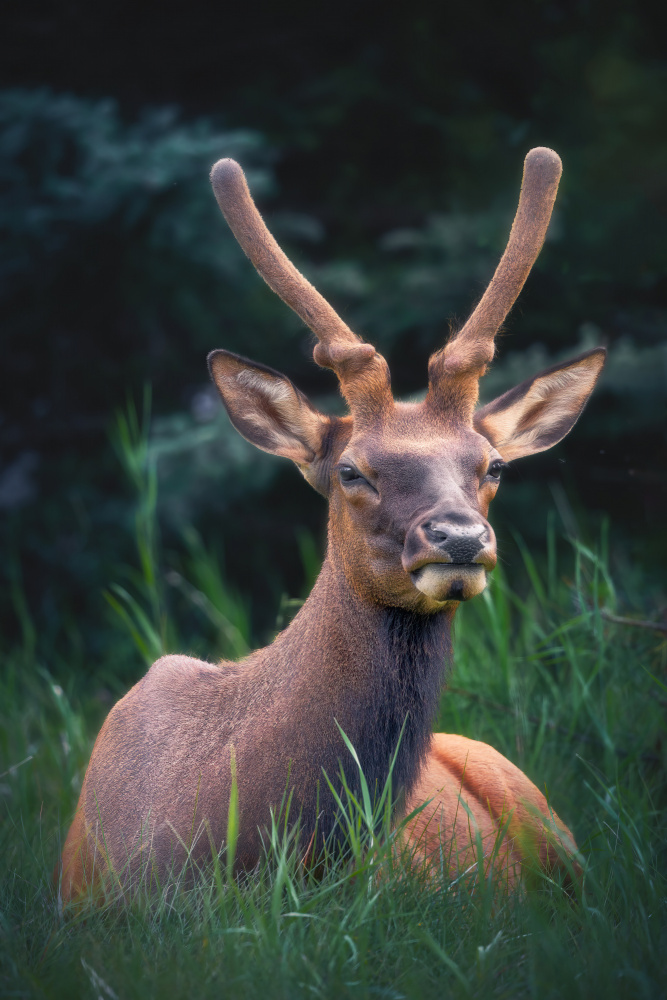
[429,146,562,414]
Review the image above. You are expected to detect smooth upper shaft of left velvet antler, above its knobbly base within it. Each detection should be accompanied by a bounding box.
[211,160,360,354]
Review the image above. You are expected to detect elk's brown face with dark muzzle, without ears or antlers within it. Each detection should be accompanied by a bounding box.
[329,403,504,611]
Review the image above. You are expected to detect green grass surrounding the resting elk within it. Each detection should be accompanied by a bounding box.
[0,423,667,1000]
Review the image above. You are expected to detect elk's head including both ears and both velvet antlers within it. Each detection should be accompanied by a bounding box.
[209,148,605,613]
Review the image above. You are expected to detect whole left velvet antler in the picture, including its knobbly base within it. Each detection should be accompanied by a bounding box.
[211,159,391,412]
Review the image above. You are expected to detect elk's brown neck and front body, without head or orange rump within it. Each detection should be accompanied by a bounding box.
[65,562,450,881]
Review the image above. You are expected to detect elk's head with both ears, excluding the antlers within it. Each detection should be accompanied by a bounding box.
[209,350,604,613]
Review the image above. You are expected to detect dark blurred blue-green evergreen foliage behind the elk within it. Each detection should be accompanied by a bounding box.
[0,0,667,660]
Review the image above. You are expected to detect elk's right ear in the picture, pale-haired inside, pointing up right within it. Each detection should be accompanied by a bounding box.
[473,347,607,462]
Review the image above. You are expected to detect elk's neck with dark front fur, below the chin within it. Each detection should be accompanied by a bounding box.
[277,559,453,820]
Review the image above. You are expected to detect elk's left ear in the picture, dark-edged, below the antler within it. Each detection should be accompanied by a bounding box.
[208,351,331,471]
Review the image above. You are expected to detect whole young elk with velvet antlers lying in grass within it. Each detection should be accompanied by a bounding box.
[62,148,605,900]
